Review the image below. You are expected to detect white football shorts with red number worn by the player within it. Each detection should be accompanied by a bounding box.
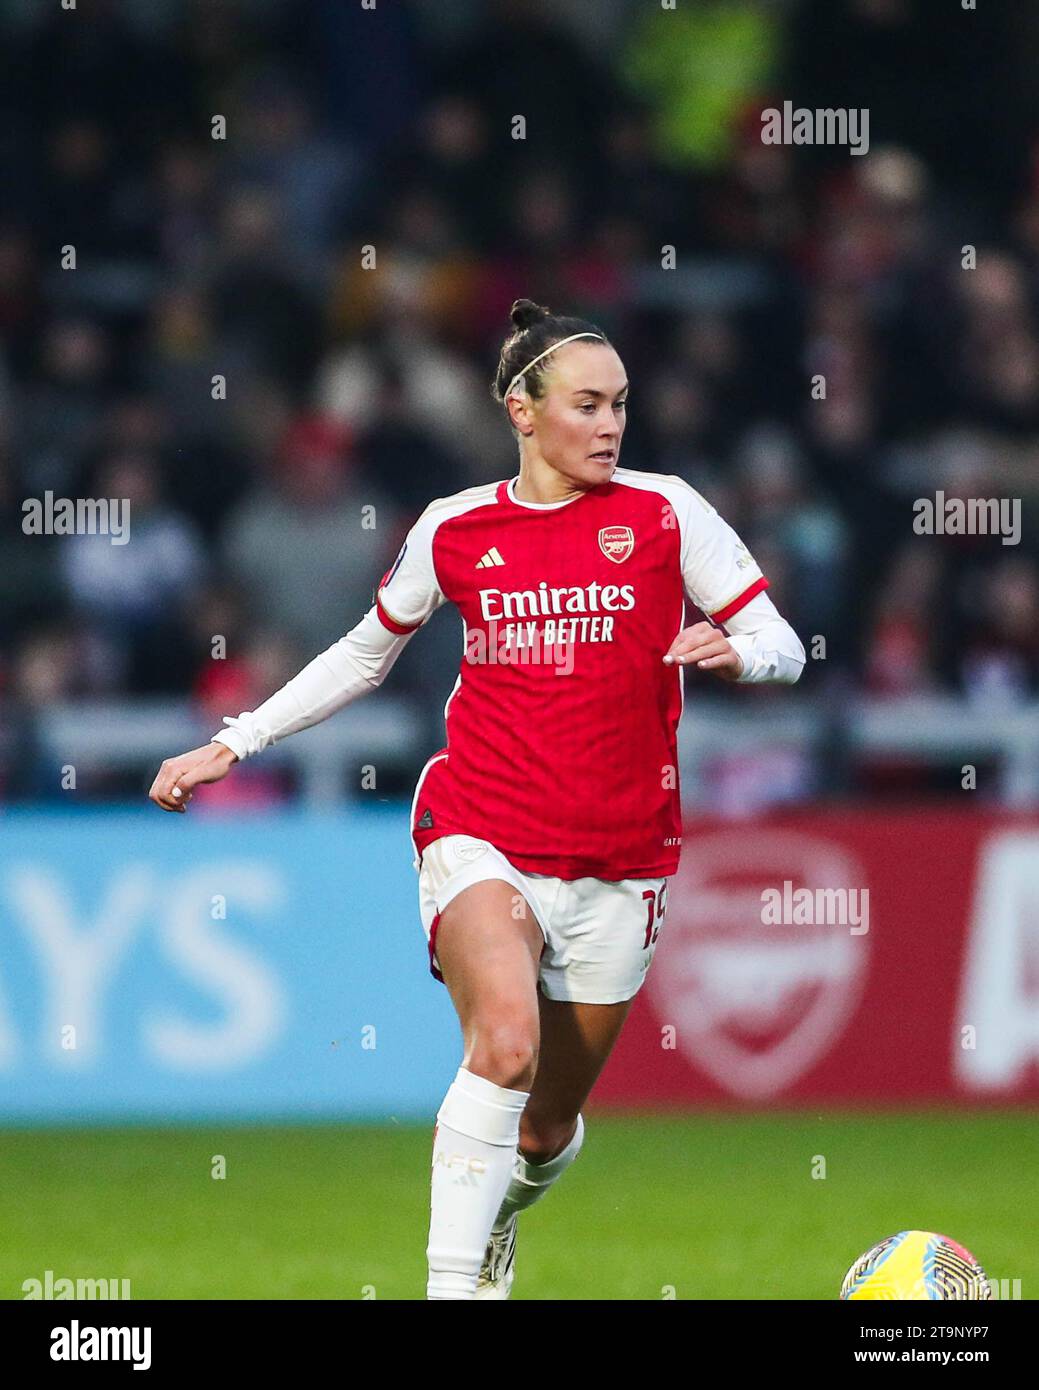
[419,835,668,1004]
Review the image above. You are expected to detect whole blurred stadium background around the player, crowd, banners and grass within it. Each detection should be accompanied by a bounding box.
[0,0,1039,1298]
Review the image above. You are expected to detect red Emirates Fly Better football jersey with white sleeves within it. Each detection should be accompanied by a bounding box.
[376,468,768,880]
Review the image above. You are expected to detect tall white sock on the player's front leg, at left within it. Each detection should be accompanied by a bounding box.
[426,1066,529,1298]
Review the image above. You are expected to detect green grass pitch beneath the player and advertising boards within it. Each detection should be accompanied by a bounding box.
[0,1111,1039,1300]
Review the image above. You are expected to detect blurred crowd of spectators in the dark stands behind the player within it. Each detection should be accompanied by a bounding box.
[0,0,1039,791]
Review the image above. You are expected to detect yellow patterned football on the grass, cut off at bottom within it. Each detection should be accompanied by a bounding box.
[840,1230,993,1300]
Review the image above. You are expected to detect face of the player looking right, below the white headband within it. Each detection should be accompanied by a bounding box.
[533,342,627,488]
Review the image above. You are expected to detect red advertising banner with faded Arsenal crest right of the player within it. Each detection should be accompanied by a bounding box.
[595,808,1039,1106]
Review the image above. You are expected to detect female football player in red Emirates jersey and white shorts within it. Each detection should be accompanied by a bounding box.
[150,299,804,1298]
